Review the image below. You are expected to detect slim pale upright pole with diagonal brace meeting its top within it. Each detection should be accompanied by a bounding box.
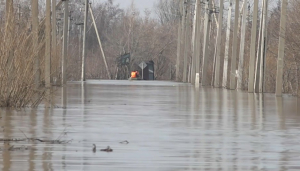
[81,0,89,81]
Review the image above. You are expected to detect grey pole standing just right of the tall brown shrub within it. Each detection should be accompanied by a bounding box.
[45,0,51,88]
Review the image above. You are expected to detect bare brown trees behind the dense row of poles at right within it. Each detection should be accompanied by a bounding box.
[173,0,300,95]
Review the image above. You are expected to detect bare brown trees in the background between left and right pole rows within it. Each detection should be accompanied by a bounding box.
[68,0,178,80]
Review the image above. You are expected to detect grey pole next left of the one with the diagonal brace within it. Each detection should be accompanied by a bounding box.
[62,0,69,86]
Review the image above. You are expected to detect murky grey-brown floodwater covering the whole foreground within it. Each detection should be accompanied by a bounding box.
[0,81,300,171]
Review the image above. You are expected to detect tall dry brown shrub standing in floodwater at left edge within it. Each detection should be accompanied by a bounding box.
[0,19,45,108]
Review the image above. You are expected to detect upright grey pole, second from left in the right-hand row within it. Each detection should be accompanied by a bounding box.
[183,0,191,83]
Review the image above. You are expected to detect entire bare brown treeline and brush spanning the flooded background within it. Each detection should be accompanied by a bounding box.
[0,0,300,107]
